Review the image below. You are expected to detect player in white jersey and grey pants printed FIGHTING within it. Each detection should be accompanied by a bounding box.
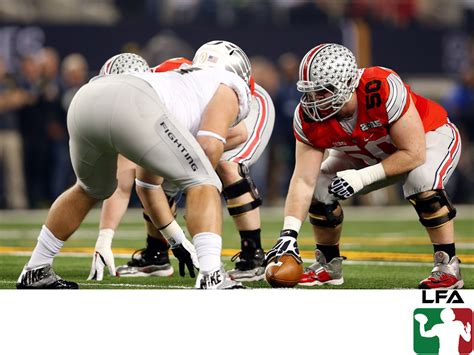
[17,41,254,289]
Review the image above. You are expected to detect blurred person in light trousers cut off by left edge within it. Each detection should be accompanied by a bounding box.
[0,59,29,208]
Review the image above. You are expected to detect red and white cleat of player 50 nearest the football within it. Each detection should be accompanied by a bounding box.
[298,249,346,286]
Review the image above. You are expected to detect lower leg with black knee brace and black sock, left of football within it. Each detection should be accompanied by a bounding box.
[216,161,265,281]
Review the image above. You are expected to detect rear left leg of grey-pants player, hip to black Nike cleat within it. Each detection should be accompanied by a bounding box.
[17,81,121,288]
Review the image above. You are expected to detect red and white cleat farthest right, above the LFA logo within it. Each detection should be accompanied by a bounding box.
[418,251,464,289]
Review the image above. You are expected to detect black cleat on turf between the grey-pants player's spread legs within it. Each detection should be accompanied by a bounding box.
[117,248,174,277]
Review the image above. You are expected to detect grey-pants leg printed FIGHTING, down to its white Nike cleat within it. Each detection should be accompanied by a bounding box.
[114,82,241,288]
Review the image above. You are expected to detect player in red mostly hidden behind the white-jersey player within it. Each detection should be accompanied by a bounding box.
[89,51,275,281]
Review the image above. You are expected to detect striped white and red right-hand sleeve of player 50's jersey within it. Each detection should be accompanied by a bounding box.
[385,72,410,124]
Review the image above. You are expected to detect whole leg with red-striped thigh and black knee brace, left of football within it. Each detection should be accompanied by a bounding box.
[217,85,275,281]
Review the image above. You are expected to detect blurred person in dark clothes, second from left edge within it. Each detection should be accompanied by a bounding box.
[19,56,49,208]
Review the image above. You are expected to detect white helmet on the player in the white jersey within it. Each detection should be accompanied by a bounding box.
[193,41,251,86]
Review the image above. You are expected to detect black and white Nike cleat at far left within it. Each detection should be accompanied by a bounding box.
[16,264,79,290]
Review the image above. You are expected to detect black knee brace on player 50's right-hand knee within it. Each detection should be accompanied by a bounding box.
[408,190,456,228]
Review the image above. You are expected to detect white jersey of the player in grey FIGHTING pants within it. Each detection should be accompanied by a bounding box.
[131,68,251,136]
